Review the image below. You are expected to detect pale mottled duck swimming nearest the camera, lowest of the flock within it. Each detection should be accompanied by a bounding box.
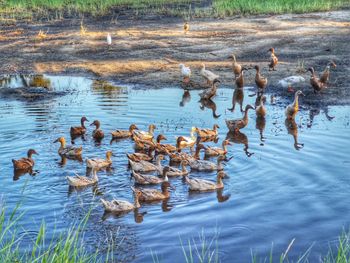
[101,191,141,213]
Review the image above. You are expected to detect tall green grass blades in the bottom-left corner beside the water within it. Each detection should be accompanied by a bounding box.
[0,206,113,263]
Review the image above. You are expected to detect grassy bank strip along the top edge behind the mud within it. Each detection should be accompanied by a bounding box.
[0,0,350,19]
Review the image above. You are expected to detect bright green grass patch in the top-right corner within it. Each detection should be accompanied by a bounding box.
[213,0,350,16]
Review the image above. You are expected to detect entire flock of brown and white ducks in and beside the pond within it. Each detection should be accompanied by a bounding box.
[12,23,336,217]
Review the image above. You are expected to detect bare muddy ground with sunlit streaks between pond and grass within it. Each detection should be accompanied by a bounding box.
[0,10,350,104]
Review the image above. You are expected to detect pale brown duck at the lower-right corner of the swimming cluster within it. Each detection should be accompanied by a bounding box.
[185,171,226,192]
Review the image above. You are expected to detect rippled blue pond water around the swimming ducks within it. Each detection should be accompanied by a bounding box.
[0,76,350,262]
